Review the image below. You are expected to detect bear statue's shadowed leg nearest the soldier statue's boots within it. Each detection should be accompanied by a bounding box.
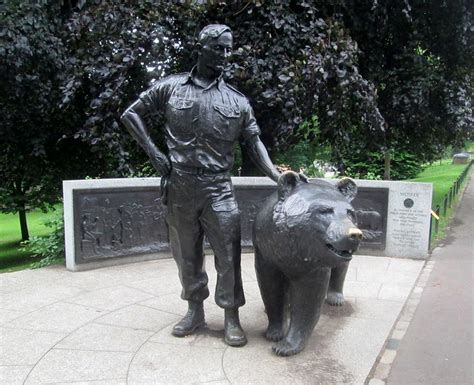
[255,249,288,341]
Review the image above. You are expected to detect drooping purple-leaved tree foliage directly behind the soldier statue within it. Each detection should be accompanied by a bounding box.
[60,0,383,172]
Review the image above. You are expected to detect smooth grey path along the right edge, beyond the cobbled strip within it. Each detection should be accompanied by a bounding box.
[387,176,474,385]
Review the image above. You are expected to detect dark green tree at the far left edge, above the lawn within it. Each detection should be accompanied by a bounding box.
[0,2,109,240]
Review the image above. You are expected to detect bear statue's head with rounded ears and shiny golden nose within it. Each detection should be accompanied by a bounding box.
[273,171,362,267]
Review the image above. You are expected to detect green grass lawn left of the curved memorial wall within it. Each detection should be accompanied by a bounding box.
[0,206,60,273]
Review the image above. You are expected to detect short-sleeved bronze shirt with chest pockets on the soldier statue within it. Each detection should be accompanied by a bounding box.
[140,69,260,172]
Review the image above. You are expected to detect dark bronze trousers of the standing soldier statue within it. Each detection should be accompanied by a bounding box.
[167,169,245,308]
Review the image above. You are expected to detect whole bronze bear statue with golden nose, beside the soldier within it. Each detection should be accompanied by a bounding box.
[253,171,362,356]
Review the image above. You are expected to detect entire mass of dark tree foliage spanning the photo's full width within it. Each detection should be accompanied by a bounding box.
[0,0,472,228]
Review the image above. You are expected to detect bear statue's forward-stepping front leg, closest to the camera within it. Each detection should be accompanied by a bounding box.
[272,268,330,356]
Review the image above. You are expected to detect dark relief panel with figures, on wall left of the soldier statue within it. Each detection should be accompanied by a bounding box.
[73,187,168,263]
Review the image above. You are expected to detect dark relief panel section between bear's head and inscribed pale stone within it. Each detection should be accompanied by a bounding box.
[352,187,388,250]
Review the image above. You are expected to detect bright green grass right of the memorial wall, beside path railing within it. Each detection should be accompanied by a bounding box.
[409,159,466,209]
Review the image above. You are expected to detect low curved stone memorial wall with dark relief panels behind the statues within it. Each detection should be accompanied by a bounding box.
[63,177,431,270]
